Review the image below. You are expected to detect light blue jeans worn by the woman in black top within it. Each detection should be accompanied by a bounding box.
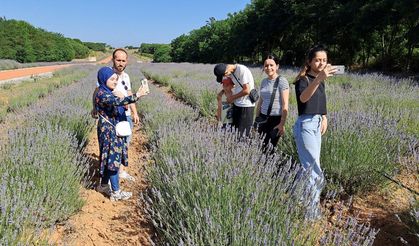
[293,114,324,209]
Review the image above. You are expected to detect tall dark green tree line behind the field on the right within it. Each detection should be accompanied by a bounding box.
[169,0,419,72]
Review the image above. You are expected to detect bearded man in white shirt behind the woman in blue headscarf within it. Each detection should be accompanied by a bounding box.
[91,48,140,181]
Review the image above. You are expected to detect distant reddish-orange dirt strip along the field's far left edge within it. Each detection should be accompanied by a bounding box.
[0,56,112,81]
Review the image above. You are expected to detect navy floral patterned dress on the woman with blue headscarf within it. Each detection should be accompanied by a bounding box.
[95,88,138,176]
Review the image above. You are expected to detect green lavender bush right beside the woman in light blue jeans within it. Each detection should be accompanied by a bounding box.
[321,110,415,194]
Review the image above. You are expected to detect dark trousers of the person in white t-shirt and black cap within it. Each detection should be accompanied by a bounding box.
[232,105,255,136]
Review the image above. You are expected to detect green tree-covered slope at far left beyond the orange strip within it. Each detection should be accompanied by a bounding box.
[0,17,106,63]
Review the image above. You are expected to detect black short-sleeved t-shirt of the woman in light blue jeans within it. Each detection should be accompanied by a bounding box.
[295,74,327,115]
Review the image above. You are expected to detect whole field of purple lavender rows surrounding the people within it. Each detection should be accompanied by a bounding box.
[0,61,419,245]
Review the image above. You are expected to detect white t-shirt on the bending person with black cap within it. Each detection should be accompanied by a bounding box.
[229,64,255,107]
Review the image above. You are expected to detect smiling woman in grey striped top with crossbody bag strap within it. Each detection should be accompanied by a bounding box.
[256,55,289,147]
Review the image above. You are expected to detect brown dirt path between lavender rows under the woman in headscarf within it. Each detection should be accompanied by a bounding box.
[50,126,152,245]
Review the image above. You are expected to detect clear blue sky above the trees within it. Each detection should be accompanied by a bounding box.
[0,0,251,47]
